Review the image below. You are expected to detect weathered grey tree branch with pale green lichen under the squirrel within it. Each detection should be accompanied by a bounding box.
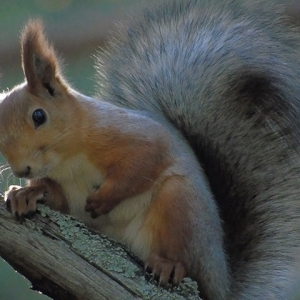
[0,200,200,300]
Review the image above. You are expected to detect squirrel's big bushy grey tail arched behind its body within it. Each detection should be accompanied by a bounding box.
[98,0,300,299]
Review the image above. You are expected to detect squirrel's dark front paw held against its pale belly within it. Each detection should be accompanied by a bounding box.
[85,192,115,219]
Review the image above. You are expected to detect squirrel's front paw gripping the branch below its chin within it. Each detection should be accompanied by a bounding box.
[4,185,46,220]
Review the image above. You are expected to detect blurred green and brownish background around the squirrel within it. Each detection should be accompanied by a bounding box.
[0,0,300,300]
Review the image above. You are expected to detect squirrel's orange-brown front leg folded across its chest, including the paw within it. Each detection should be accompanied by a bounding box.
[86,127,169,217]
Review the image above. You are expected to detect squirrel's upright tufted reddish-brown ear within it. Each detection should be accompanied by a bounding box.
[21,20,66,97]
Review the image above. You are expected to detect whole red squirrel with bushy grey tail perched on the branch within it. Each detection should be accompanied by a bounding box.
[0,0,300,300]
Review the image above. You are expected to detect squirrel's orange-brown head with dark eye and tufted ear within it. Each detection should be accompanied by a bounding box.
[0,20,84,178]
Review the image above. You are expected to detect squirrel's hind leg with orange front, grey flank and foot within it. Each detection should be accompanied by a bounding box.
[142,174,229,299]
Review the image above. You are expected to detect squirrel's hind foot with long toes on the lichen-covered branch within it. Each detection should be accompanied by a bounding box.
[145,253,186,286]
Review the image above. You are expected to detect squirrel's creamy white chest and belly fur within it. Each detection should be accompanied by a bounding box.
[51,155,152,258]
